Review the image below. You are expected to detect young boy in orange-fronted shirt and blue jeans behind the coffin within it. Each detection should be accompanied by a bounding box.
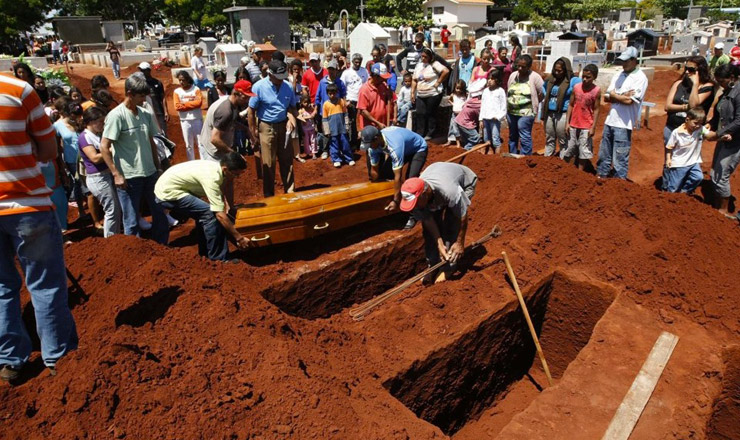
[321,83,355,168]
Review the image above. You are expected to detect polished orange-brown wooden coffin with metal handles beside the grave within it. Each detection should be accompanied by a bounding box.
[234,182,393,246]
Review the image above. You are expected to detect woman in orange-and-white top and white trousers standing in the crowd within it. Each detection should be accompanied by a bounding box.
[173,70,203,160]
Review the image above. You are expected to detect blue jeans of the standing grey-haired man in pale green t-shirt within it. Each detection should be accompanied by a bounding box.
[117,173,169,244]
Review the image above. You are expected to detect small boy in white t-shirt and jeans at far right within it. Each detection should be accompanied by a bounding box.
[663,107,732,193]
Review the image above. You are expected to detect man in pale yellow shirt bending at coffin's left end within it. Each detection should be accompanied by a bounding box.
[154,151,249,260]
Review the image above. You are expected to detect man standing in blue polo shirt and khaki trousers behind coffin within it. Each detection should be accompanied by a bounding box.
[248,60,296,197]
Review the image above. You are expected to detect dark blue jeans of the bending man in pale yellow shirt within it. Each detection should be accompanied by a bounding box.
[157,195,229,261]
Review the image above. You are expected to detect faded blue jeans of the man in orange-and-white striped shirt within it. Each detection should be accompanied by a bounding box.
[0,211,77,368]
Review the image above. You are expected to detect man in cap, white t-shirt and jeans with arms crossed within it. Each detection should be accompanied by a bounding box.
[597,46,648,179]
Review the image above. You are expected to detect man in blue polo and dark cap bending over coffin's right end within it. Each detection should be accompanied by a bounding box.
[361,125,427,229]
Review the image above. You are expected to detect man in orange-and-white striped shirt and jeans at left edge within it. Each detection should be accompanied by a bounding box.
[0,74,77,382]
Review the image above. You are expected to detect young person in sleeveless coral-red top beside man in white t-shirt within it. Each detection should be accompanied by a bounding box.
[560,64,601,170]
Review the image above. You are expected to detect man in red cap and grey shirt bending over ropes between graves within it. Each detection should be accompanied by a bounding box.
[400,162,478,283]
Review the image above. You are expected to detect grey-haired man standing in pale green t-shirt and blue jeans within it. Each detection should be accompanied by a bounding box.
[100,74,169,244]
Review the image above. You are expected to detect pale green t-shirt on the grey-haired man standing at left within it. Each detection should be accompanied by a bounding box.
[103,104,157,179]
